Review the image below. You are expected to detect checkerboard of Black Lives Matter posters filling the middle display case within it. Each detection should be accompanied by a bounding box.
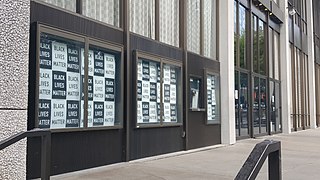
[137,59,178,124]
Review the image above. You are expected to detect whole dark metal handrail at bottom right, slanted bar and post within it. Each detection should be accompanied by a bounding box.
[235,140,282,180]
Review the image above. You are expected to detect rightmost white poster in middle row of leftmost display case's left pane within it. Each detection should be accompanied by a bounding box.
[67,72,80,100]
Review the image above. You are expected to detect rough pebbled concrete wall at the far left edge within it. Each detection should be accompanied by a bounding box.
[0,0,30,179]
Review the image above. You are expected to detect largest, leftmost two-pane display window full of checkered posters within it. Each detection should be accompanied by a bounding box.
[36,25,123,129]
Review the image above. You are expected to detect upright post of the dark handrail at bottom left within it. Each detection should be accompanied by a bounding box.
[41,132,51,180]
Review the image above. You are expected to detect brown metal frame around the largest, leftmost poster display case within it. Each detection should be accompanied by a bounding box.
[34,23,124,132]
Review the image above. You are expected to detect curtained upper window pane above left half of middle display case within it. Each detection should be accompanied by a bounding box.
[130,0,155,39]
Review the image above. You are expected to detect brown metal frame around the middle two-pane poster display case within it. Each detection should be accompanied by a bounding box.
[133,50,183,129]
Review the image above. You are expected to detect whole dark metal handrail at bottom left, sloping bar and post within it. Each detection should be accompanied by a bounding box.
[0,129,51,180]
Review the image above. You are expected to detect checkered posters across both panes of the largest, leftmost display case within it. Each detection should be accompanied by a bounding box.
[38,33,117,129]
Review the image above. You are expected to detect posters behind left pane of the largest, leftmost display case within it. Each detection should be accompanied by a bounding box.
[38,33,83,129]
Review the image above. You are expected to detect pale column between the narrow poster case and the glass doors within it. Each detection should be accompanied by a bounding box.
[218,0,236,144]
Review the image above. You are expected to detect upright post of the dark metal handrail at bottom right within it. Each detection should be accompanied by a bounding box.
[268,145,282,180]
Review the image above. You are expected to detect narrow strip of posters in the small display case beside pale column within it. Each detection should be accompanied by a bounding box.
[207,74,219,121]
